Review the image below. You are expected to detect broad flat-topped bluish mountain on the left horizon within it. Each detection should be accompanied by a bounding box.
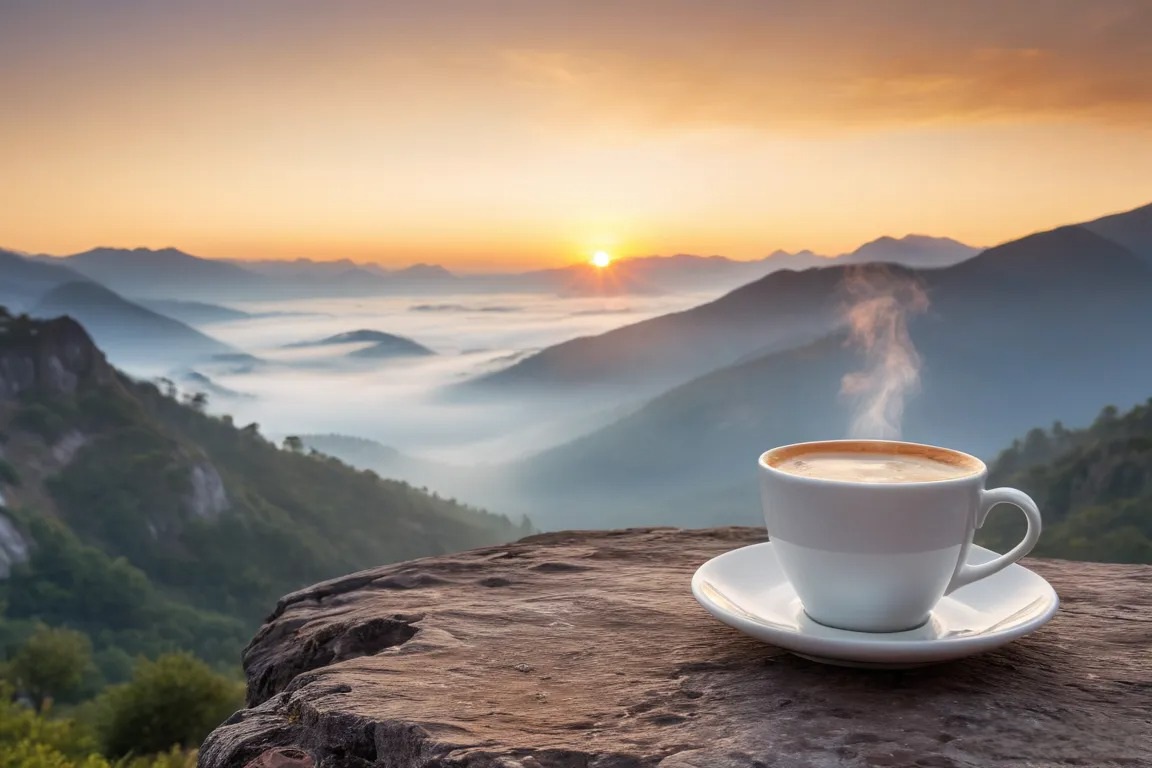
[56,248,265,299]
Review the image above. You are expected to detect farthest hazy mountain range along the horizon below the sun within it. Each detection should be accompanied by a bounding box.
[9,235,979,303]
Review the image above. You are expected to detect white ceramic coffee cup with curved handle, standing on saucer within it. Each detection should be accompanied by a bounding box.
[759,440,1040,632]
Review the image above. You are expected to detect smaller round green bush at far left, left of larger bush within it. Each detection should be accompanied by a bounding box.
[8,626,92,710]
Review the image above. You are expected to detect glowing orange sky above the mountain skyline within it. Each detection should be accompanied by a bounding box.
[0,0,1152,269]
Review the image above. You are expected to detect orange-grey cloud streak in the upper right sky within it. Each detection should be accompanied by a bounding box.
[501,0,1152,132]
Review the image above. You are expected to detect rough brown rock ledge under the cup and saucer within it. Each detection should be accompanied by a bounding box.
[200,529,1152,768]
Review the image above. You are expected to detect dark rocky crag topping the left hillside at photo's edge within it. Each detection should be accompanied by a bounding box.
[0,314,116,401]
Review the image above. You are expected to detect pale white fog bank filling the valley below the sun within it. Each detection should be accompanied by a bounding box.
[167,292,714,465]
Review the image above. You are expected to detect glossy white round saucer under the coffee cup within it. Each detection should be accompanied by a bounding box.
[692,541,1060,669]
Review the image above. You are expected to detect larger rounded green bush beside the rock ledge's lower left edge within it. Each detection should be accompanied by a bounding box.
[99,653,243,758]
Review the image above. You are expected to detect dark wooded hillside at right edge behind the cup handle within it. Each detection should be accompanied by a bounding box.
[980,400,1152,563]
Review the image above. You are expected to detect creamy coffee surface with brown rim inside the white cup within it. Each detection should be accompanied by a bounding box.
[775,451,976,482]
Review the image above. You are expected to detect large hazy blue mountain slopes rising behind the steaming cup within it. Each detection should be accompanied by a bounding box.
[465,208,1152,527]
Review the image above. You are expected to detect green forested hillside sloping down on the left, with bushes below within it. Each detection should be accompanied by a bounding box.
[0,313,522,755]
